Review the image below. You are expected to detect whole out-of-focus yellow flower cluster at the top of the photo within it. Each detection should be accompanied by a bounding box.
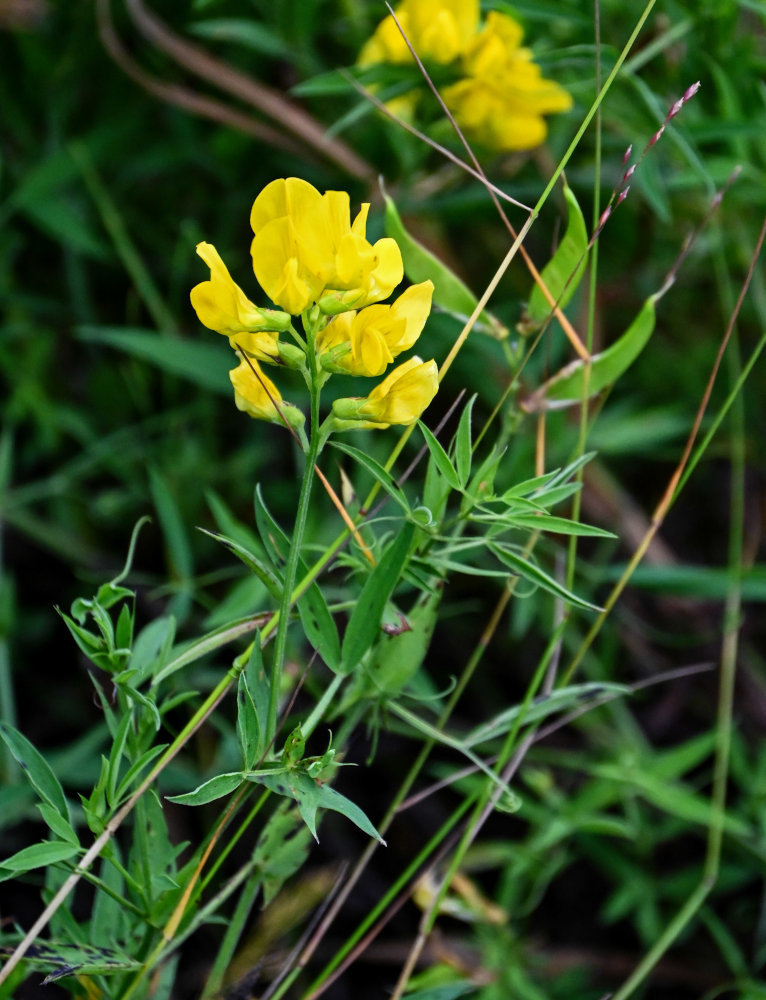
[358,0,572,152]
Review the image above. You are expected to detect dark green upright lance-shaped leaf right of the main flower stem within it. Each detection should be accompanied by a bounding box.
[340,522,415,674]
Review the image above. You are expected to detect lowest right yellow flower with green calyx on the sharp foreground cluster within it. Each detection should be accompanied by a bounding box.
[332,357,439,429]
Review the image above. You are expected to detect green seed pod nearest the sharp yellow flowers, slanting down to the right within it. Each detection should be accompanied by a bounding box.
[384,194,508,340]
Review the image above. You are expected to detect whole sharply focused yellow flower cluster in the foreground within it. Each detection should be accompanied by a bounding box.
[191,177,438,429]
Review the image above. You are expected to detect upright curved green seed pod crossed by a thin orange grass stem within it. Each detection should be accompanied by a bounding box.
[519,181,588,333]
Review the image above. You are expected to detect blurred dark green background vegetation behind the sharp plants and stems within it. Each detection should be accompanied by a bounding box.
[0,0,766,1000]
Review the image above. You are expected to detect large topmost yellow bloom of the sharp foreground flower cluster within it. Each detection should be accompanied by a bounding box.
[250,177,404,315]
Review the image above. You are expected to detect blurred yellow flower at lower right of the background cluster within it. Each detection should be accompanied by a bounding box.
[443,11,572,152]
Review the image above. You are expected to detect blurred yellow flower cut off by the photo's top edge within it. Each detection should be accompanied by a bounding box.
[358,0,479,66]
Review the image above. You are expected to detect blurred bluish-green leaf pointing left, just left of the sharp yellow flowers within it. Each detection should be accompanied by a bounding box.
[75,326,233,396]
